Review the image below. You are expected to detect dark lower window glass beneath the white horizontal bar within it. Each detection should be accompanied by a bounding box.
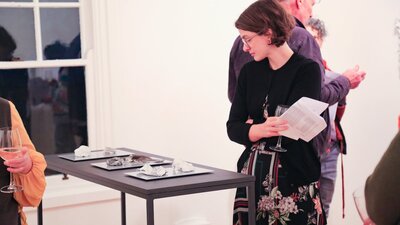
[0,67,88,160]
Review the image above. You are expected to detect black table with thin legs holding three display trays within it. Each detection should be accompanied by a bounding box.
[42,148,256,225]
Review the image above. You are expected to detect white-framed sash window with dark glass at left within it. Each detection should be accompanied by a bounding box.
[0,0,88,174]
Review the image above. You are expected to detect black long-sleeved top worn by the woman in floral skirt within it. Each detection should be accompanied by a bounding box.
[227,53,321,185]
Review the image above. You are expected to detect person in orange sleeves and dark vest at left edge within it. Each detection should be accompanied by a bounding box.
[0,98,47,225]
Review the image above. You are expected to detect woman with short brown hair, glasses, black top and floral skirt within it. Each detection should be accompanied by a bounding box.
[227,0,326,225]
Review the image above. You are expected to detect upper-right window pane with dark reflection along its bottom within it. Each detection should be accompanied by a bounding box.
[40,8,81,59]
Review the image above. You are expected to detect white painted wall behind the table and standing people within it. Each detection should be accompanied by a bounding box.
[32,0,400,225]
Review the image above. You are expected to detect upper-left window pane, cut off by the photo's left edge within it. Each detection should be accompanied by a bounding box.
[0,8,36,61]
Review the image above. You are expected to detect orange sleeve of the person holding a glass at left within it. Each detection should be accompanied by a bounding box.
[9,102,47,207]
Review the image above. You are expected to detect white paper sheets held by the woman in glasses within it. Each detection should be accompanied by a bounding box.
[280,97,328,142]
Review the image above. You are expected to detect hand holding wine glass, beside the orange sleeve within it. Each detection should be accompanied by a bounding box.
[4,147,32,174]
